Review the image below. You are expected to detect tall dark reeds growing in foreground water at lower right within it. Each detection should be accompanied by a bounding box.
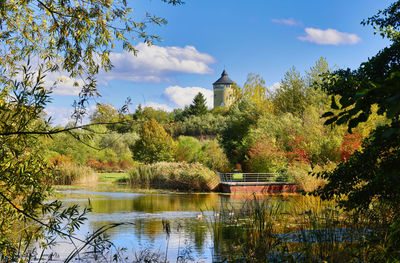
[209,196,400,262]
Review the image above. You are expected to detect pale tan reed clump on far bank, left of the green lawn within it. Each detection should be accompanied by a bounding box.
[54,163,98,185]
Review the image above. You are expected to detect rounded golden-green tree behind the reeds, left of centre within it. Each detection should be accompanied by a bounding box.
[131,119,175,163]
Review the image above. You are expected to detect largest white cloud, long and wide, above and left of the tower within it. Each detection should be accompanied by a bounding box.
[102,43,215,82]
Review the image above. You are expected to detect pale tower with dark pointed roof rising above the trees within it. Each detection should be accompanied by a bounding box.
[213,69,233,109]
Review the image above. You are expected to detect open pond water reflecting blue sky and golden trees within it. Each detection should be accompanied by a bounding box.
[49,185,300,262]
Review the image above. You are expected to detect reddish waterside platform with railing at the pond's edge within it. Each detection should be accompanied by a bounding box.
[218,173,299,193]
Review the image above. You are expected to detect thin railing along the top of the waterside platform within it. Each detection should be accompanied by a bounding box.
[218,173,292,183]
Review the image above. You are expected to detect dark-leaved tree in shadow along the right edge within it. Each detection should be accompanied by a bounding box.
[314,1,400,212]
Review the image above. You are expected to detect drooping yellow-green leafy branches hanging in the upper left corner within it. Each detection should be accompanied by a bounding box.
[0,0,182,119]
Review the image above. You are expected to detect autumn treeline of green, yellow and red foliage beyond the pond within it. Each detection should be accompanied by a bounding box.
[42,58,386,185]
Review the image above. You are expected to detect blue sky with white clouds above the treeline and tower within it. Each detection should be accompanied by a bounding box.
[46,0,391,125]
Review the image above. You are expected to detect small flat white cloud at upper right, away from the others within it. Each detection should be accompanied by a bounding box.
[298,27,361,45]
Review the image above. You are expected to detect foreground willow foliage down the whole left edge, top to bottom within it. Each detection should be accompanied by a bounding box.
[0,0,182,262]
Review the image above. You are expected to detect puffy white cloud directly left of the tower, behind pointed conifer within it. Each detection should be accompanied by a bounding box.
[163,86,214,108]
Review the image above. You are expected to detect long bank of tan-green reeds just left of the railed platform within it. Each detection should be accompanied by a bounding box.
[129,162,219,191]
